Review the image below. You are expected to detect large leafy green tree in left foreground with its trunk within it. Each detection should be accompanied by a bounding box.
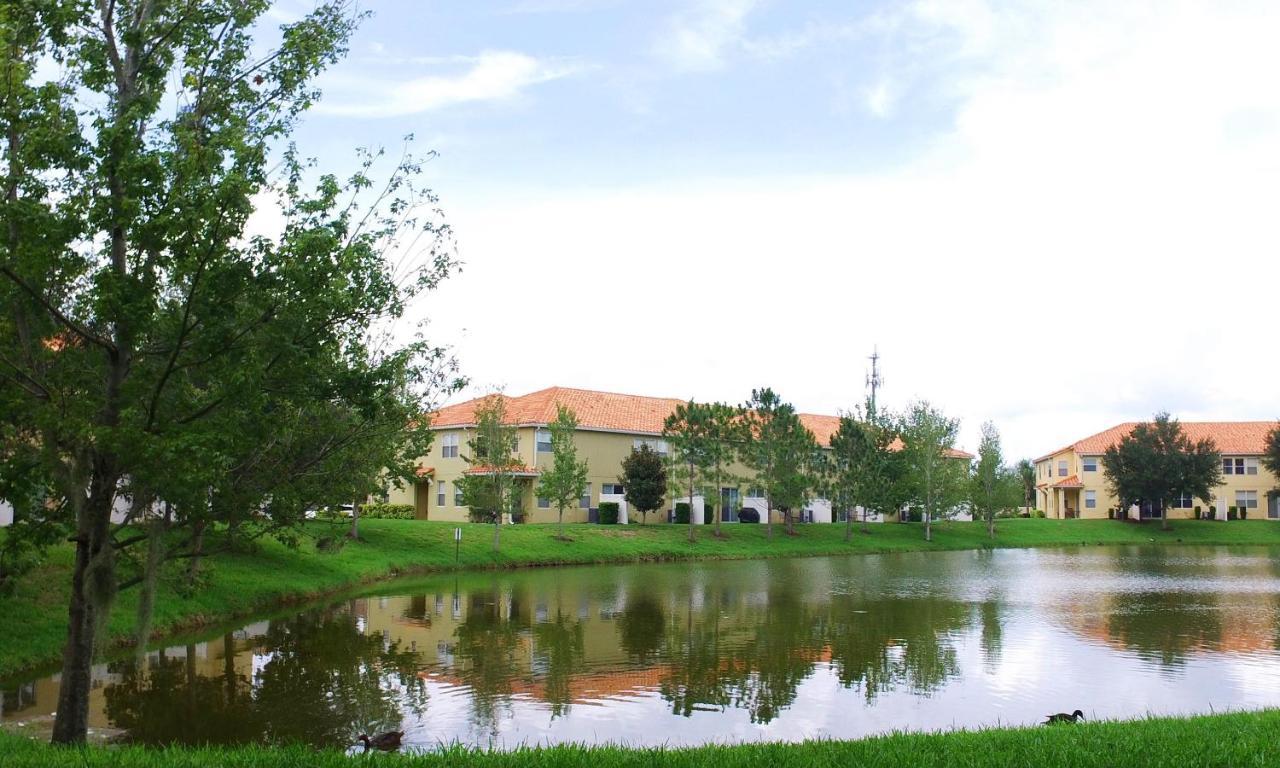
[0,0,454,742]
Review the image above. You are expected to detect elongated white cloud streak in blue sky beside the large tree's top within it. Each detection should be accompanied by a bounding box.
[315,51,582,118]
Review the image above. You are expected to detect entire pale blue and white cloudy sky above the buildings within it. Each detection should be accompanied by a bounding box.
[262,0,1280,461]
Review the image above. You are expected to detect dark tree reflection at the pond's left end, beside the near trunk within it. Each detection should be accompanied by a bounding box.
[105,611,426,746]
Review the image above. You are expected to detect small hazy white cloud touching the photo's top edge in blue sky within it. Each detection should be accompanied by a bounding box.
[654,0,758,72]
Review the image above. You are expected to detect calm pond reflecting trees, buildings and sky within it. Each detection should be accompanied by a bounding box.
[0,547,1280,749]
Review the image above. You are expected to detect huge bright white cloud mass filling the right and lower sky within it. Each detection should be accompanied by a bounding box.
[430,1,1280,457]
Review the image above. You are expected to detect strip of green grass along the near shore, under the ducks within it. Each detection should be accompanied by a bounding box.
[0,709,1280,768]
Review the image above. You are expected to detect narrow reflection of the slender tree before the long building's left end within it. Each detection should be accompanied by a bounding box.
[454,588,520,737]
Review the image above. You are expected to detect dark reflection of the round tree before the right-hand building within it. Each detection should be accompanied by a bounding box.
[1106,591,1222,667]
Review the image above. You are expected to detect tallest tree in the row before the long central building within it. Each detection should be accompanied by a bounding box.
[740,388,818,539]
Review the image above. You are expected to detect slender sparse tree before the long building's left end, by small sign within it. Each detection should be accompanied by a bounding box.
[460,392,522,552]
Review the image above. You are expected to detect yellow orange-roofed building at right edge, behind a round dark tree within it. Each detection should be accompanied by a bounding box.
[1036,421,1280,520]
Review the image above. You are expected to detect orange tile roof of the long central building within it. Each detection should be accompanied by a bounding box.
[431,387,973,458]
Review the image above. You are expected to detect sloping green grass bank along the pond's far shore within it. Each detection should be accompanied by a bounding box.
[0,520,1280,678]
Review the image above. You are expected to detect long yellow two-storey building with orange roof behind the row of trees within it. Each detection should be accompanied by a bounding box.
[388,387,970,522]
